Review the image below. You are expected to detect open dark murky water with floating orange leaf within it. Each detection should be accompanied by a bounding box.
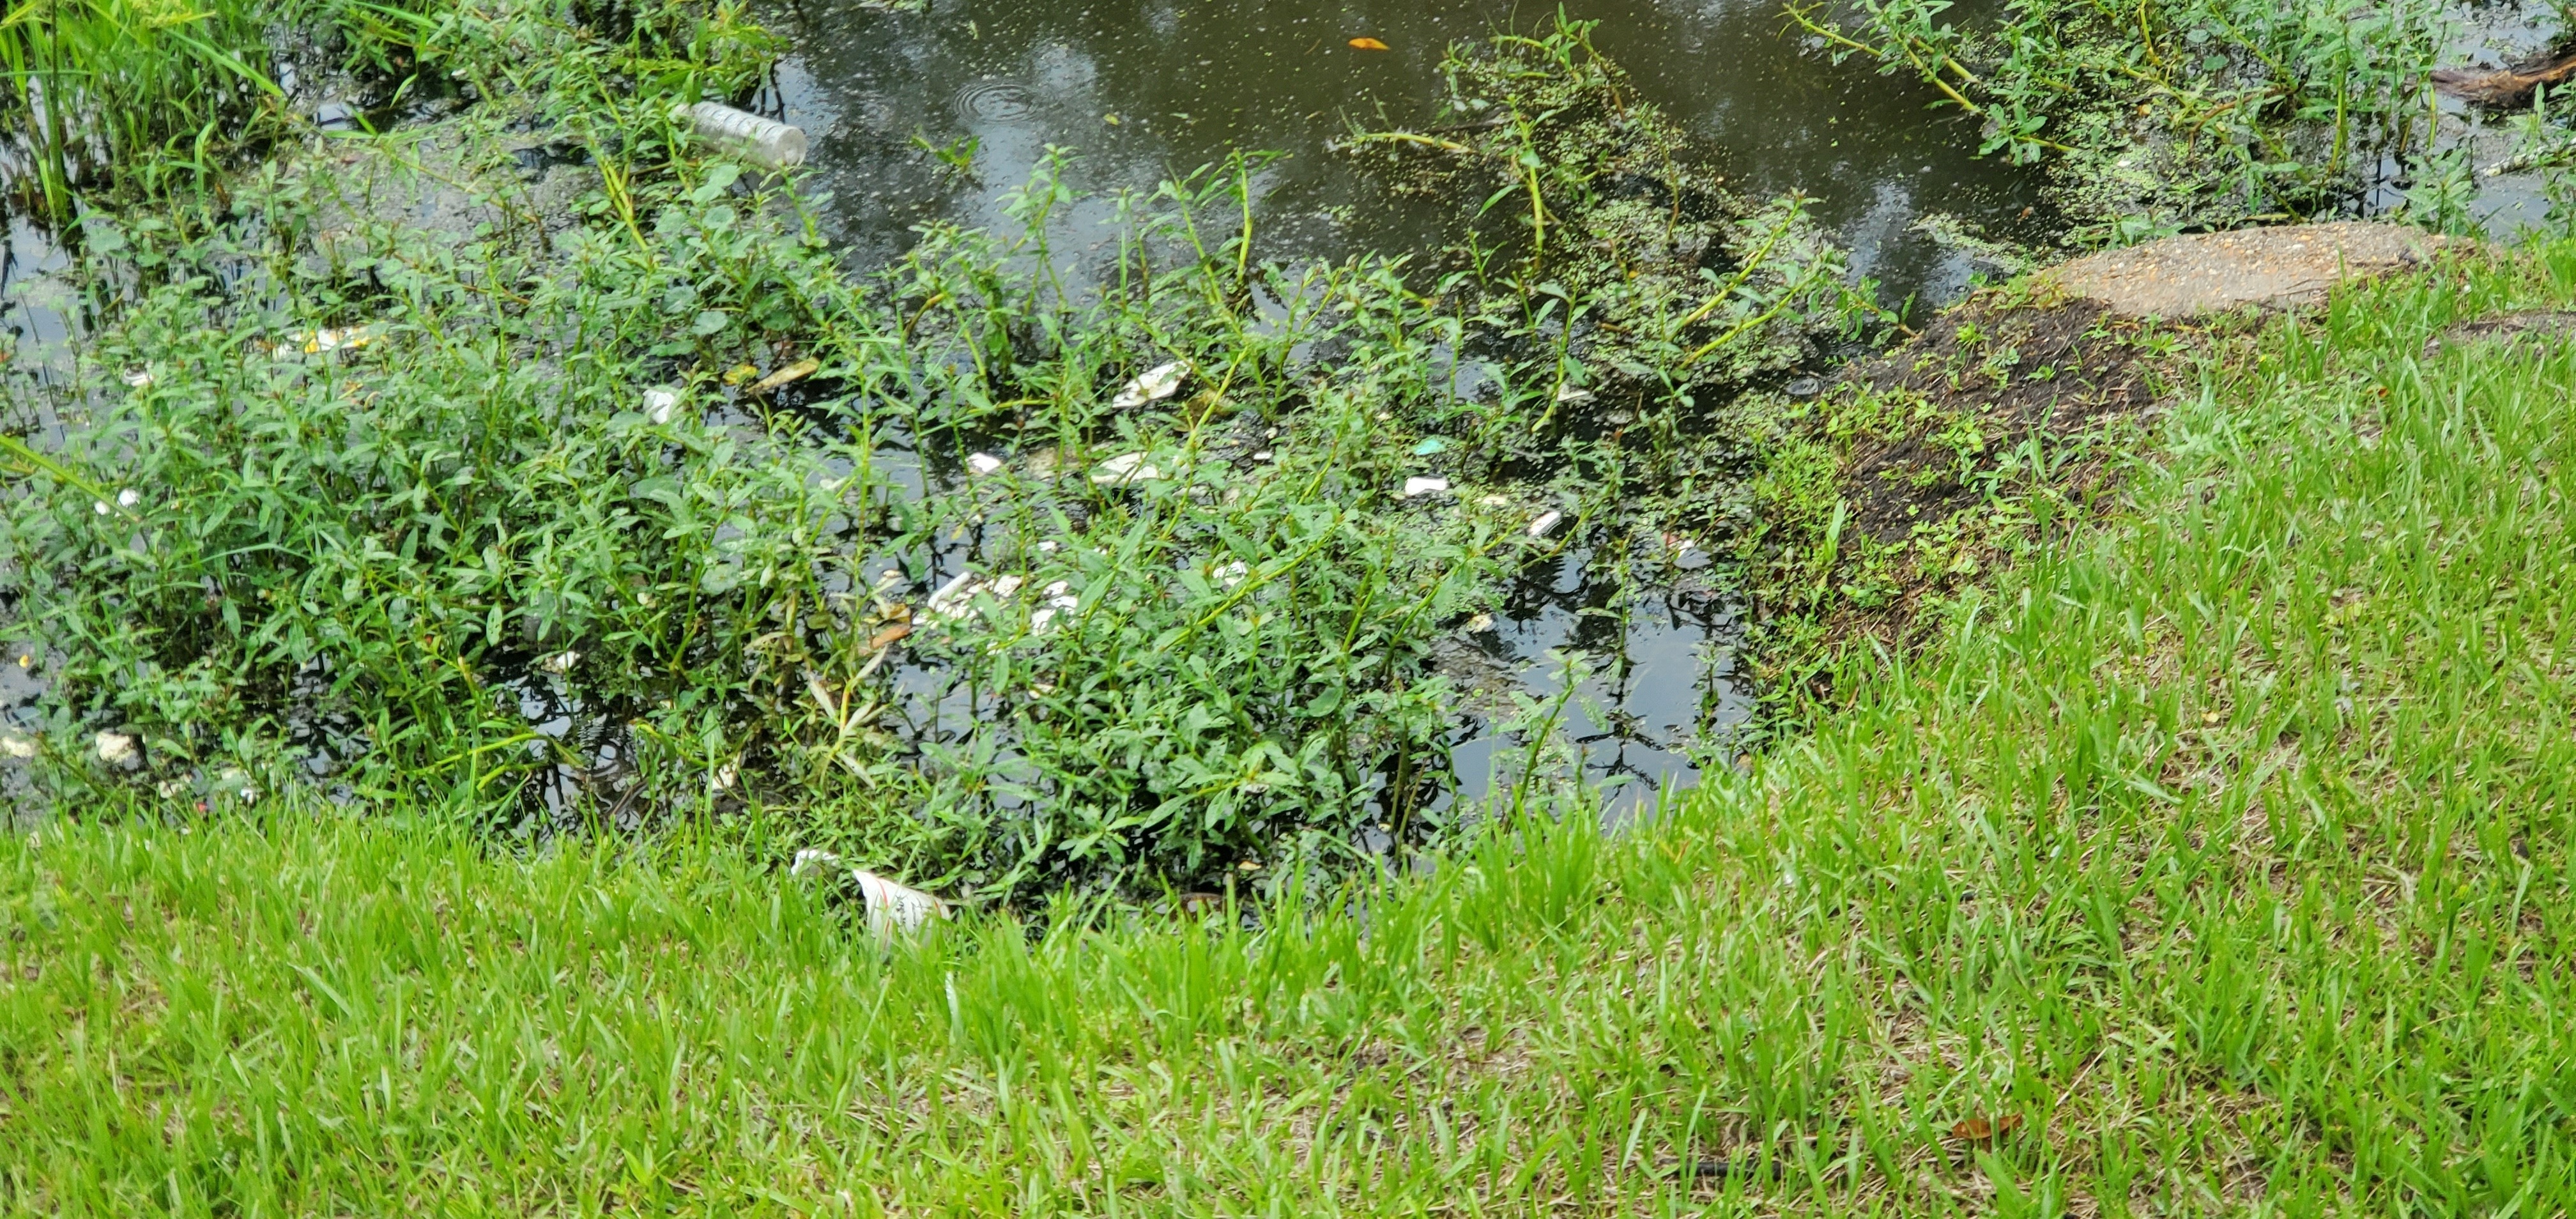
[762,0,2045,302]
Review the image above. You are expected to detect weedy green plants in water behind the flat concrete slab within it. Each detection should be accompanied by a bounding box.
[1788,0,2463,245]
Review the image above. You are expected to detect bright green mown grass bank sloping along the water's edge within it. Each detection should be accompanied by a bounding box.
[15,247,2576,1216]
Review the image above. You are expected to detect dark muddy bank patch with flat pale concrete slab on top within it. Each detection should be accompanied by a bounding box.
[1744,222,2452,698]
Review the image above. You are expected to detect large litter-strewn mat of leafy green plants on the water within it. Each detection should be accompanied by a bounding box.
[0,10,1867,902]
